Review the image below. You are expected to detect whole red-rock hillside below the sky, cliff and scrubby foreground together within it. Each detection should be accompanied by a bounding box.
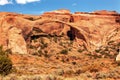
[0,10,120,80]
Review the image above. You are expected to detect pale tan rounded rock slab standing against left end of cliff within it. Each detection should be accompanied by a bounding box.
[8,27,27,54]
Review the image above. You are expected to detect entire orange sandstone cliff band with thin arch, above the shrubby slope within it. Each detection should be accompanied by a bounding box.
[0,10,120,60]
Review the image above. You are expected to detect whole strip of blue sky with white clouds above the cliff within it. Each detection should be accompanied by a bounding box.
[0,0,120,15]
